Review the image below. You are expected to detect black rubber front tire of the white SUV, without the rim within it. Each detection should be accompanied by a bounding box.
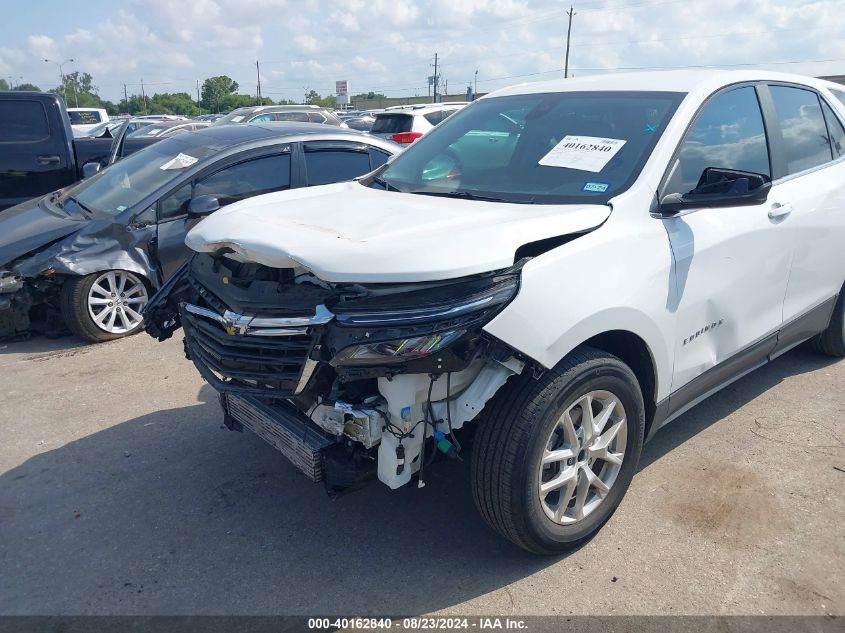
[472,347,645,554]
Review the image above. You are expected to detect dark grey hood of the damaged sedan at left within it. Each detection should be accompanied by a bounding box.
[0,198,89,266]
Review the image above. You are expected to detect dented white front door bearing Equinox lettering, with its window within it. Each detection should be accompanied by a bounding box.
[660,85,791,400]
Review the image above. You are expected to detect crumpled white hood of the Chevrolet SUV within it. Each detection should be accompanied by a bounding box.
[185,182,610,283]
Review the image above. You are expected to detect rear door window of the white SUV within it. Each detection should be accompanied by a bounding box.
[769,86,832,174]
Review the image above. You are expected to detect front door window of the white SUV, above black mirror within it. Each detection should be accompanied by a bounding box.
[663,86,772,195]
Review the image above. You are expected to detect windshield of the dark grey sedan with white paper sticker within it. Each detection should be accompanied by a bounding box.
[59,134,219,215]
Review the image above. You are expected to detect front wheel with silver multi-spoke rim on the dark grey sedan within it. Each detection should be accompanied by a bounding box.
[61,270,150,343]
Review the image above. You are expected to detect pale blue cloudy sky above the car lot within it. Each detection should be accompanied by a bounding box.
[0,0,845,101]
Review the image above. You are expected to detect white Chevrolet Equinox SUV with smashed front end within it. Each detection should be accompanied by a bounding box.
[148,71,845,553]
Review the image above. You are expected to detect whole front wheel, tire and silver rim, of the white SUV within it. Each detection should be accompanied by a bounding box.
[471,347,645,554]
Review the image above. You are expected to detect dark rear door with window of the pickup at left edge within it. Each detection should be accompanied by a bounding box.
[0,95,76,209]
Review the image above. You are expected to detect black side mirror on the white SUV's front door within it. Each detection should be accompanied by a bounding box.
[659,167,772,217]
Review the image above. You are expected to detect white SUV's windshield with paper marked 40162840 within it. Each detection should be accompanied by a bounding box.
[380,92,683,204]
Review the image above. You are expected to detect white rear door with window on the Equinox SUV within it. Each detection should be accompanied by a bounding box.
[756,84,845,352]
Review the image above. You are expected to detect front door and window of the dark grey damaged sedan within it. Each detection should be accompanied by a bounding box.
[155,146,291,281]
